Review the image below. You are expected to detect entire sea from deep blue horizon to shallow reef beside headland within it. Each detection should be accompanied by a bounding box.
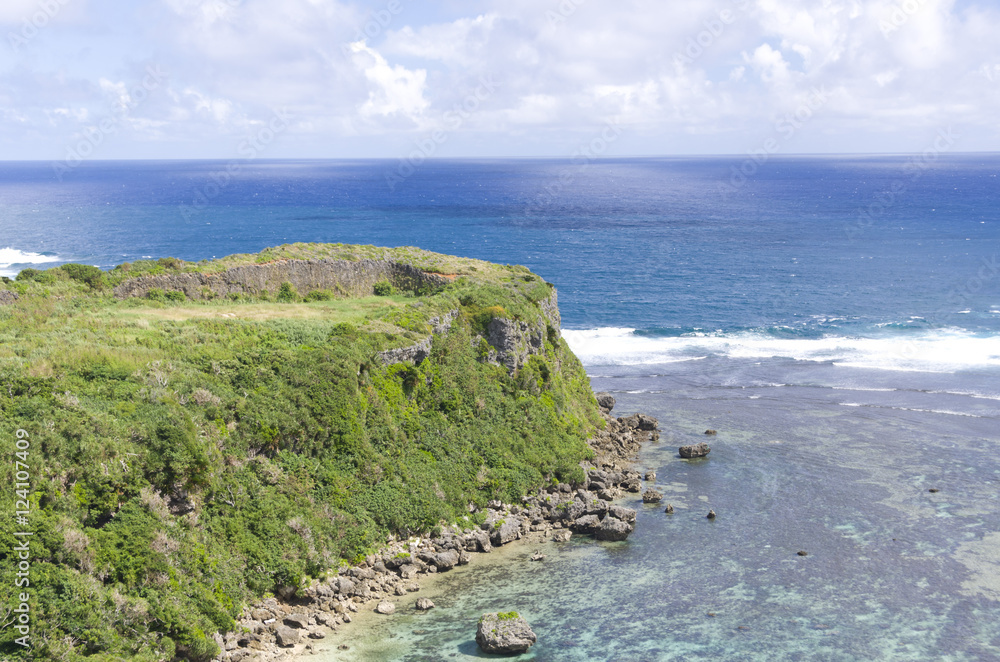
[0,154,1000,662]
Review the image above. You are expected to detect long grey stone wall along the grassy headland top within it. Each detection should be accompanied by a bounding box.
[114,260,448,299]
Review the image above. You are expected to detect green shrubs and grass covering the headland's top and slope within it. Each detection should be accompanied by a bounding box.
[0,246,599,660]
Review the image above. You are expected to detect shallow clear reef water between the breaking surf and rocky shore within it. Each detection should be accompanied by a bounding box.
[319,392,1000,662]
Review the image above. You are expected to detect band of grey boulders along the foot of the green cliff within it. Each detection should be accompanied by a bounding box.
[215,393,659,662]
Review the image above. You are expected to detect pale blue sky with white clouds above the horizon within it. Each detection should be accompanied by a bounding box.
[0,0,1000,163]
